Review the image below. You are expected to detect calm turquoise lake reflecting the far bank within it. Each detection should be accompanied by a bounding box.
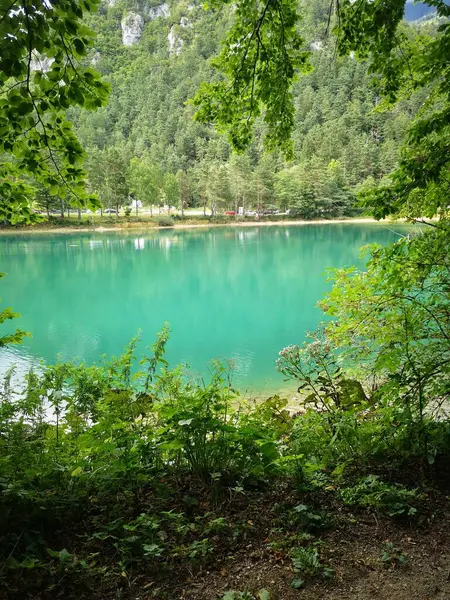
[0,223,418,393]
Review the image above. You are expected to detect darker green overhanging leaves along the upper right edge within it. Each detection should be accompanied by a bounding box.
[338,0,450,218]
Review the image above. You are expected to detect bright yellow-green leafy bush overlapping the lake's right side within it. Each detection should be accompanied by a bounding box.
[321,223,450,446]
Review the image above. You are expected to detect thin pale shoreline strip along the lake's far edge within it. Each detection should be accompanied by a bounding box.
[0,217,406,235]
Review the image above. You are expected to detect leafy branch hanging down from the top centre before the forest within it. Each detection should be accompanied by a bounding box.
[194,0,309,155]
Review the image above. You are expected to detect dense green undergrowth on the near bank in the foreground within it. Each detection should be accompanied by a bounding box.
[0,328,443,600]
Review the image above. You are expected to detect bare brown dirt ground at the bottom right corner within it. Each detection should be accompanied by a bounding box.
[130,498,450,600]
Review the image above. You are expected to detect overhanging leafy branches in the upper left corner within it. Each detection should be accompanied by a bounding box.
[0,0,109,223]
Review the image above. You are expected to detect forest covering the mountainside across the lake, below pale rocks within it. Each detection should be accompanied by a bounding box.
[14,0,436,219]
